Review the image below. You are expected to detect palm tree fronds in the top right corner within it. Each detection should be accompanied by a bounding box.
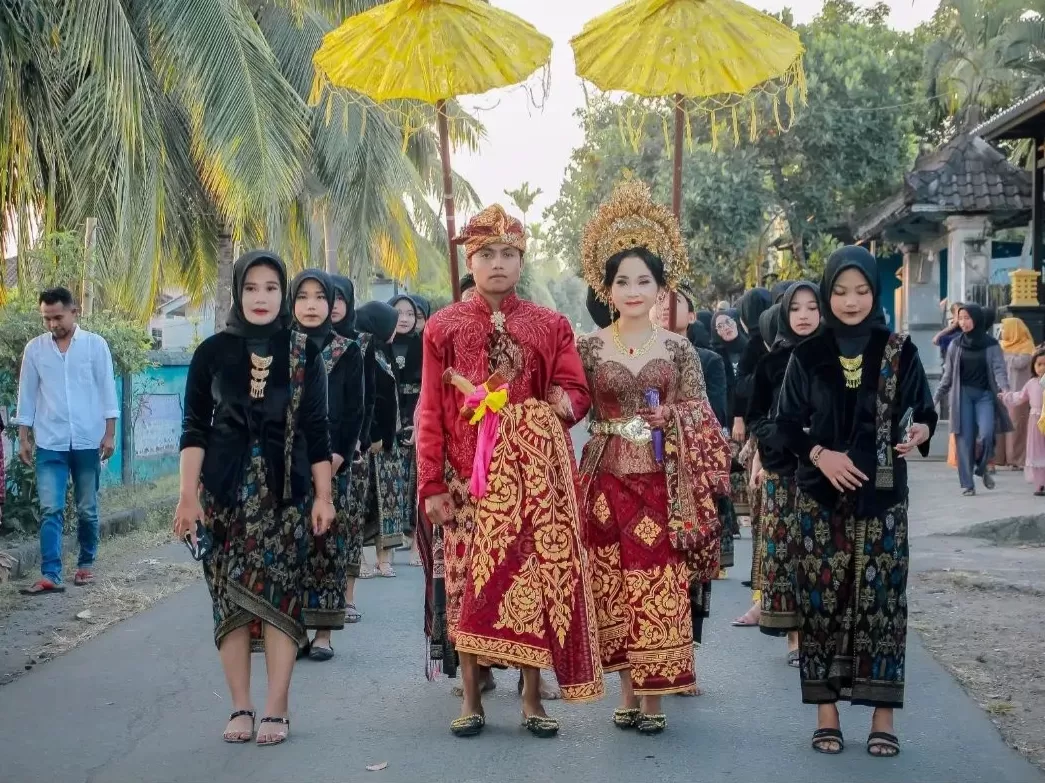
[925,0,1045,132]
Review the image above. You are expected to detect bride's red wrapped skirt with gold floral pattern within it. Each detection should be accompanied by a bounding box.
[584,471,703,695]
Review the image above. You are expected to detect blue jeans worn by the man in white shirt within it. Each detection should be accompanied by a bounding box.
[37,448,101,584]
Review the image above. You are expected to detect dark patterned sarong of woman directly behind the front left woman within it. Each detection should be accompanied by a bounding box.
[304,470,348,630]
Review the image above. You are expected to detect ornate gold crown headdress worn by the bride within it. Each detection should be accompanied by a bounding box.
[581,180,690,303]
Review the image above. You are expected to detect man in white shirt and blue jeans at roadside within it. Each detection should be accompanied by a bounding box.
[15,287,119,595]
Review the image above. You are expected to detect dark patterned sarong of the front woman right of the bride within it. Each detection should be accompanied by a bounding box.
[795,490,909,708]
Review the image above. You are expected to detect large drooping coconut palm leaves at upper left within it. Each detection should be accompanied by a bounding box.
[0,0,481,320]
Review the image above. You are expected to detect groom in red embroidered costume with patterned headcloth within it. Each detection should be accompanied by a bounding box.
[417,205,603,737]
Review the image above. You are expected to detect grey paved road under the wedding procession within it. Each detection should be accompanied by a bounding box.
[0,528,1045,783]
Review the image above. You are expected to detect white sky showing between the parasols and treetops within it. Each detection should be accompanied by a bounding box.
[454,0,939,225]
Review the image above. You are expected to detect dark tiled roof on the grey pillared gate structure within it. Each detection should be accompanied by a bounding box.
[855,134,1032,238]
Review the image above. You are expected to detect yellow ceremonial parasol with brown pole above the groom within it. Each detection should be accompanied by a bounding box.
[314,0,552,301]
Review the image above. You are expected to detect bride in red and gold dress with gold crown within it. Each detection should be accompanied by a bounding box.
[578,181,729,734]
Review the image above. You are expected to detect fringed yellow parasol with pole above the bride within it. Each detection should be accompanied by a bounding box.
[571,0,806,321]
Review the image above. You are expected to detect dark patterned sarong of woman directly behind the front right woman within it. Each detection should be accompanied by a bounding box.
[759,473,800,634]
